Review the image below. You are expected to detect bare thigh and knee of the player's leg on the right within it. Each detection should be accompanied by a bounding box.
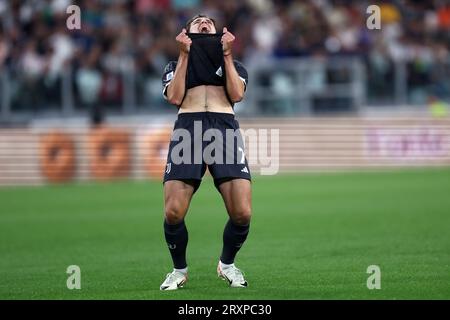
[219,178,252,224]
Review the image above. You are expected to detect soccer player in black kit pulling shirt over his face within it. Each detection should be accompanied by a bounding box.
[160,15,251,290]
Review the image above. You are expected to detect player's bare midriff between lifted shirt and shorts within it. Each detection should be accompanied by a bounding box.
[178,86,234,114]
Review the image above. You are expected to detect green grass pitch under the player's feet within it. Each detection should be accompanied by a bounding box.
[0,169,450,300]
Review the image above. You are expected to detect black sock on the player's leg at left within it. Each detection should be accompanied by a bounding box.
[164,219,188,269]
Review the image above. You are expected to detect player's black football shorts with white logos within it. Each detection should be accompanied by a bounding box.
[164,112,251,191]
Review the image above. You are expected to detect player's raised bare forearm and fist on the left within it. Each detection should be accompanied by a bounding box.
[166,29,192,106]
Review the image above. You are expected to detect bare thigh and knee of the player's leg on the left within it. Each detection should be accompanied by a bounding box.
[164,180,194,223]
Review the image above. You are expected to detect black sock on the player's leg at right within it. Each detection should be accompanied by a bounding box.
[220,219,250,264]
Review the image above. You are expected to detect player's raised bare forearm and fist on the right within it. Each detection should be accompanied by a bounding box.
[222,28,245,103]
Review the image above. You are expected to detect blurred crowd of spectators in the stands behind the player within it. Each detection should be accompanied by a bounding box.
[0,0,450,114]
